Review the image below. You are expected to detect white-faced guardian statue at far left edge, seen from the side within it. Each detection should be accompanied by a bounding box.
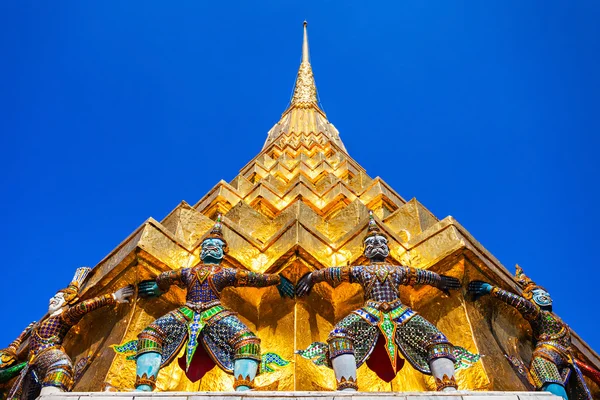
[2,267,133,399]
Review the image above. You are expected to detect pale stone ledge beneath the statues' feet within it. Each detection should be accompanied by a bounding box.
[39,391,562,400]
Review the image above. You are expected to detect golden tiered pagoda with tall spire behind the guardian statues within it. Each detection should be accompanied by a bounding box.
[5,23,600,396]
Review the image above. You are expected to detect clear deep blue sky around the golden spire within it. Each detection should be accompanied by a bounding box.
[0,0,600,350]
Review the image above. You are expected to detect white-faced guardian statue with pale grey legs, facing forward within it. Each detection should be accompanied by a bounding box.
[297,213,478,390]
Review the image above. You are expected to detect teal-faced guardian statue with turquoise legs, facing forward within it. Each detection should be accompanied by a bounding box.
[135,216,293,391]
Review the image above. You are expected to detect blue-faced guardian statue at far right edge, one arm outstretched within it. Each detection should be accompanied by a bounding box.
[469,265,592,400]
